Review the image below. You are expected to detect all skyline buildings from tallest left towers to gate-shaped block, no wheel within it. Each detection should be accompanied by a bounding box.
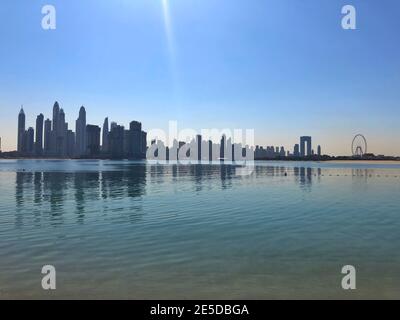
[17,102,322,160]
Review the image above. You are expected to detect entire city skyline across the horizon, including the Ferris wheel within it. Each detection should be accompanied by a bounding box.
[0,101,396,161]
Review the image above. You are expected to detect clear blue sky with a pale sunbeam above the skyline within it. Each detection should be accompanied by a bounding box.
[0,0,400,155]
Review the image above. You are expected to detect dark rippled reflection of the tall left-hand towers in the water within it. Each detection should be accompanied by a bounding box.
[15,165,146,226]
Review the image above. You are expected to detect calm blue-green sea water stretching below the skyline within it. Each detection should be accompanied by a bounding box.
[0,160,400,299]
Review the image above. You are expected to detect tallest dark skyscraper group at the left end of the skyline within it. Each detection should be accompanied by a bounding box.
[17,102,147,159]
